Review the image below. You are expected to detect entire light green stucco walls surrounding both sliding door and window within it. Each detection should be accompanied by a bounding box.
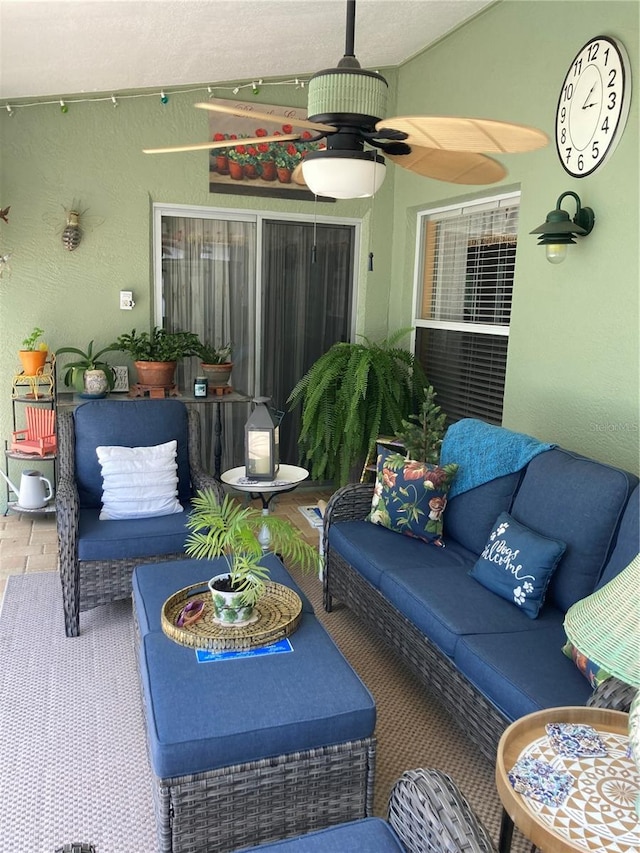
[0,0,640,509]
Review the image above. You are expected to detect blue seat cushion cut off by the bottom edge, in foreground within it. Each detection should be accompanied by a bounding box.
[238,817,405,853]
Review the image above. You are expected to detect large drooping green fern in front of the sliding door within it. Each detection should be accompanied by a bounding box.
[287,329,428,485]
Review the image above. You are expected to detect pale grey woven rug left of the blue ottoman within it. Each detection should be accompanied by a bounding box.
[0,572,157,853]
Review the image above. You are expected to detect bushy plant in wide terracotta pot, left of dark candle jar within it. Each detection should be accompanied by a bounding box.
[110,326,200,388]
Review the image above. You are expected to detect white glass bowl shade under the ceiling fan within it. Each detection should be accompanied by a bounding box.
[302,149,386,199]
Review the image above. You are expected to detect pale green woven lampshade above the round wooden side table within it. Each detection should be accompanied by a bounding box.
[564,554,640,687]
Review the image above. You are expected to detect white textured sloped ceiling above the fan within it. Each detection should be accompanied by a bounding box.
[0,0,494,100]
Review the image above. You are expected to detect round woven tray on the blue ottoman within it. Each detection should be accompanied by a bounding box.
[161,581,302,651]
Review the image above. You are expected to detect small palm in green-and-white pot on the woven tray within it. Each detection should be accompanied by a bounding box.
[185,489,320,627]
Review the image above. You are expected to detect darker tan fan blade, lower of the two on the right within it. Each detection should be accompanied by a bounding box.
[384,145,507,184]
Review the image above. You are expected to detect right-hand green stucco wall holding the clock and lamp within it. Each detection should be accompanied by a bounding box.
[390,0,640,472]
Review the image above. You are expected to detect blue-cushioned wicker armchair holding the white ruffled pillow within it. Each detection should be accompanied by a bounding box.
[56,399,221,637]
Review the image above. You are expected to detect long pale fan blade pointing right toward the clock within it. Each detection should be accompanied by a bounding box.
[376,116,549,154]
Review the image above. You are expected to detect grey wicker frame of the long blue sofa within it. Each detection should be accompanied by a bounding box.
[323,483,633,764]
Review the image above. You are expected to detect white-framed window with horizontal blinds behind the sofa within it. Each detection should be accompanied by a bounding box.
[414,193,520,424]
